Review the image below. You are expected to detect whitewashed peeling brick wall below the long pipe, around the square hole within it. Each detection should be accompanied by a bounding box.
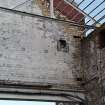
[0,7,81,90]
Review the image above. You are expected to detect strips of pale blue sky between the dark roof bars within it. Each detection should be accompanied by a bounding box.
[74,0,105,25]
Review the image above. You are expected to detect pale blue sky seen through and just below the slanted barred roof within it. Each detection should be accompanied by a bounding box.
[71,0,105,36]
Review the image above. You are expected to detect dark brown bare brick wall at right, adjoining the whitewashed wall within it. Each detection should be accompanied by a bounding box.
[82,28,105,105]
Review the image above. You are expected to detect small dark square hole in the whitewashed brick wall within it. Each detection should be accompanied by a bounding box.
[57,39,69,52]
